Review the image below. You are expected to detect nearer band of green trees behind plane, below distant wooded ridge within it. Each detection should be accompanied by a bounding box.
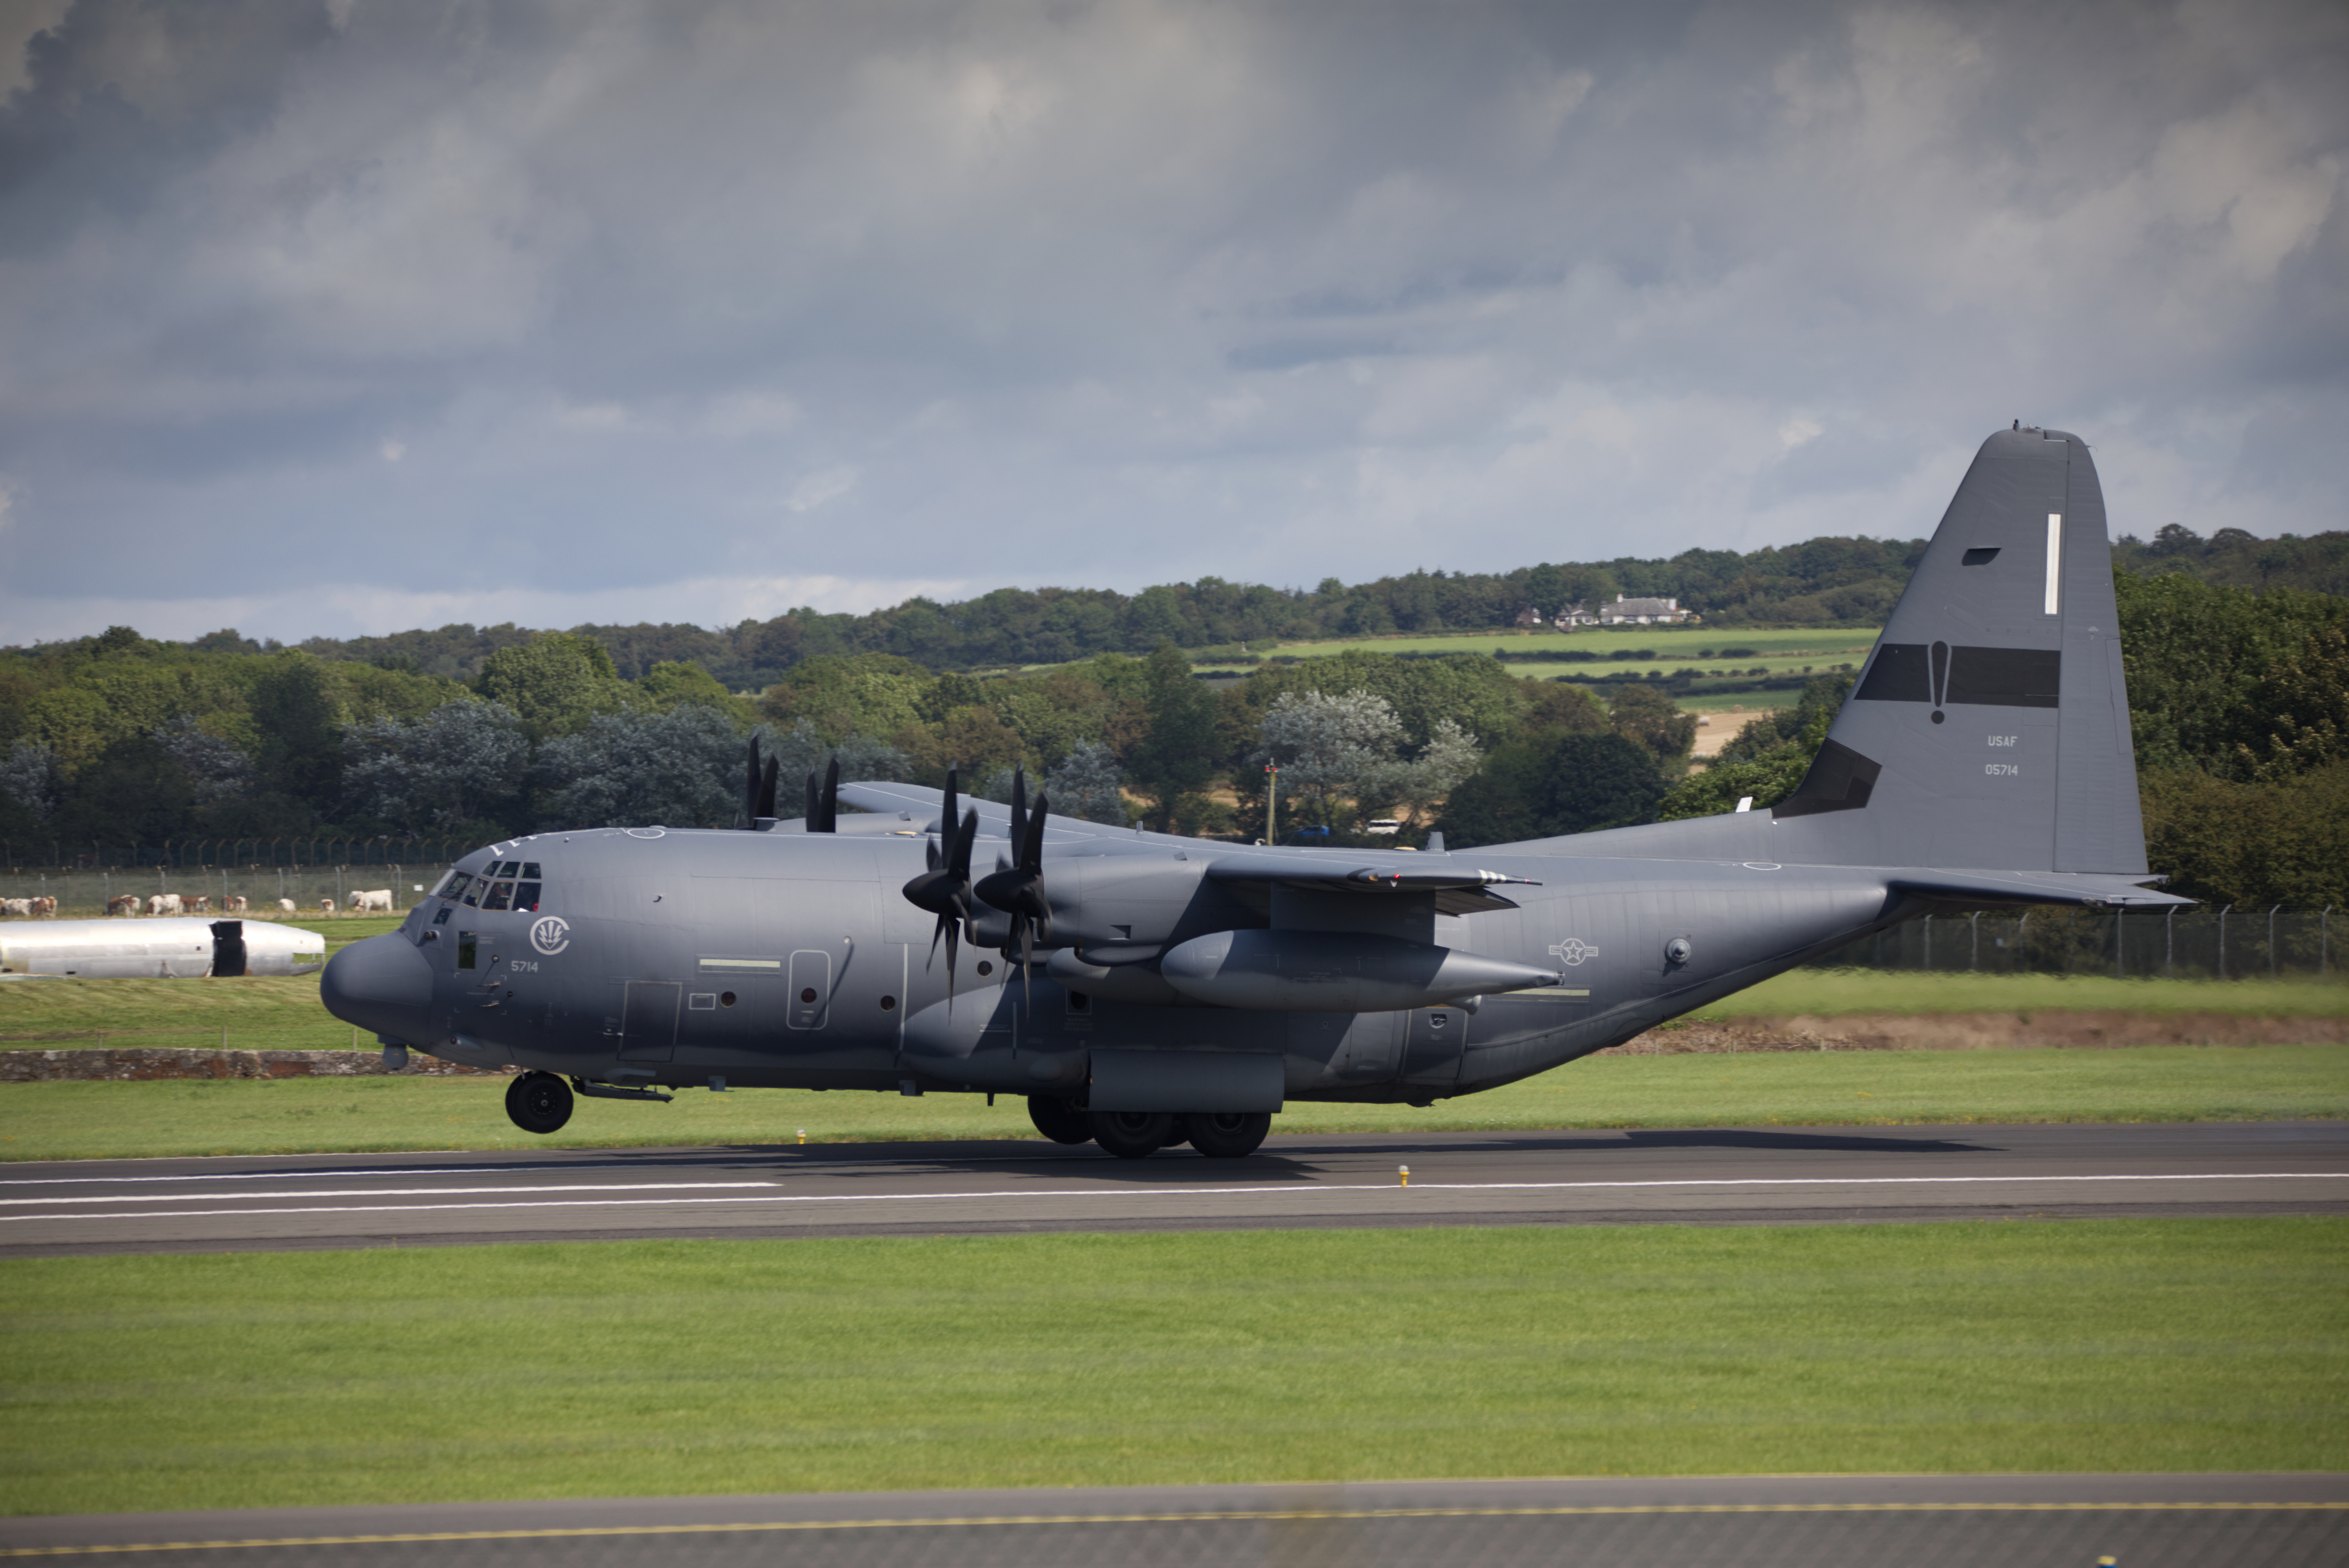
[0,556,2349,906]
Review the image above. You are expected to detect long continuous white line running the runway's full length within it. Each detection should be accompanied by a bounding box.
[0,1171,2349,1223]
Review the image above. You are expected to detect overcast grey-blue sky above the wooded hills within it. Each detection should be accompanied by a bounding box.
[0,0,2349,643]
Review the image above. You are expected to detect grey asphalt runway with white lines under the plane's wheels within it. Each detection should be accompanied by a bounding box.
[0,1122,2349,1258]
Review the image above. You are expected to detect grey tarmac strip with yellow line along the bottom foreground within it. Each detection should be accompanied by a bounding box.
[0,1474,2349,1568]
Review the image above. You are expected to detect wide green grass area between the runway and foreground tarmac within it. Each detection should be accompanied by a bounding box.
[0,1218,2349,1514]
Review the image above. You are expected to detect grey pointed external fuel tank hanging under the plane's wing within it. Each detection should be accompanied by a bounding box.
[1158,930,1557,1012]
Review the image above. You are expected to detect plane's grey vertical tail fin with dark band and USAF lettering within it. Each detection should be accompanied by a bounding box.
[1774,429,2145,873]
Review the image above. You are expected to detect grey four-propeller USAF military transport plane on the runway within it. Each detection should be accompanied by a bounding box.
[322,427,2189,1157]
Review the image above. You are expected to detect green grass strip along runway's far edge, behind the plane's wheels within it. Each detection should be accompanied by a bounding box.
[0,1045,2349,1159]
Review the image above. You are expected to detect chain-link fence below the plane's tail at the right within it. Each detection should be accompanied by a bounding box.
[1811,904,2340,979]
